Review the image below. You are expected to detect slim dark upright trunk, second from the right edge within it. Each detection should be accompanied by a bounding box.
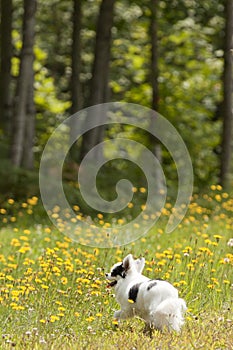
[149,0,163,189]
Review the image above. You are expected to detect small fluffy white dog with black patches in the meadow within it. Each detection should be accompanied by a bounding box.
[106,254,187,331]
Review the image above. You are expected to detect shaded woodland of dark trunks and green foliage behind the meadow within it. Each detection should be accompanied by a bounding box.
[0,0,233,199]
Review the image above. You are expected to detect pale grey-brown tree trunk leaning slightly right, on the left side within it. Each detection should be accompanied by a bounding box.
[11,0,36,166]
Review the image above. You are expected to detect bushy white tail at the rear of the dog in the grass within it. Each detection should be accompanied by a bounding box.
[152,298,187,332]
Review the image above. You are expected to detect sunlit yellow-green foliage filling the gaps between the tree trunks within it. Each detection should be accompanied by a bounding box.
[0,0,230,198]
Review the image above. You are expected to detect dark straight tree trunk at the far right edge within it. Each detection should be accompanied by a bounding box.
[220,0,233,188]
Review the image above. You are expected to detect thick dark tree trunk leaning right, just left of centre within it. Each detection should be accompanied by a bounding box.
[81,0,115,159]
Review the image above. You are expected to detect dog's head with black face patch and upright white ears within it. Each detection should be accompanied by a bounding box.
[106,254,145,287]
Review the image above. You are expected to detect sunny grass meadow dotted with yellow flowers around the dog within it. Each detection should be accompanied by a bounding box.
[0,186,233,350]
